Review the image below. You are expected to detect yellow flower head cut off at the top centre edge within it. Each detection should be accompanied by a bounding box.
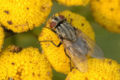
[57,0,89,6]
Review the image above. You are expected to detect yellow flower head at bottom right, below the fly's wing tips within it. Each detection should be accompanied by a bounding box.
[65,59,120,80]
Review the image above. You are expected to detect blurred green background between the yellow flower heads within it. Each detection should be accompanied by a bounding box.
[4,1,120,80]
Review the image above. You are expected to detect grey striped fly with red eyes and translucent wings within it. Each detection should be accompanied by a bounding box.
[42,15,104,72]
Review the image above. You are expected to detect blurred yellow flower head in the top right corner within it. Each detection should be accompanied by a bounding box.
[90,0,120,33]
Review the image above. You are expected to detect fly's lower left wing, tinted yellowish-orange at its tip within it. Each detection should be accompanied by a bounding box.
[64,40,88,72]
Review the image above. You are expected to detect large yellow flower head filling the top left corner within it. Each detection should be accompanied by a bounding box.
[0,0,52,33]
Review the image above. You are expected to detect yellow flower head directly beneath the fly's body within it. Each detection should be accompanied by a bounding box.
[39,11,94,74]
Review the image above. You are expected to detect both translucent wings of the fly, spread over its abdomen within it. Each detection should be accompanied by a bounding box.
[63,31,104,72]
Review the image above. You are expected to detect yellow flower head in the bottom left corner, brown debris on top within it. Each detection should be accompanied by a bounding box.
[0,46,52,80]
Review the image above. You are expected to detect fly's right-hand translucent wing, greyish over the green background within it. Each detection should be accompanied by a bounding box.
[76,30,104,59]
